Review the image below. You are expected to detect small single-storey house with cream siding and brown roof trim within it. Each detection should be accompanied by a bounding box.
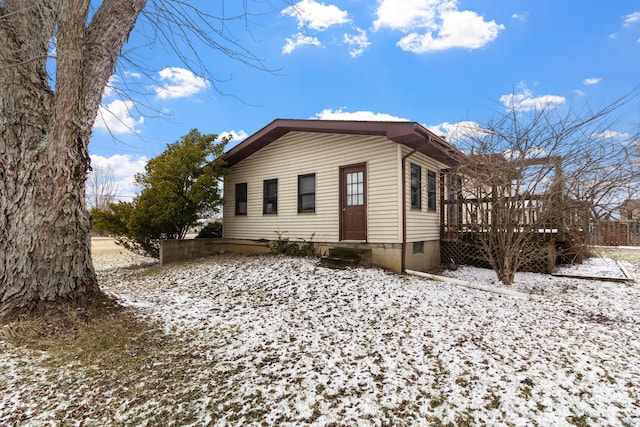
[223,119,460,271]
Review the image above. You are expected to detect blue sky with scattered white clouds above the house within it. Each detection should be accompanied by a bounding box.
[89,0,640,198]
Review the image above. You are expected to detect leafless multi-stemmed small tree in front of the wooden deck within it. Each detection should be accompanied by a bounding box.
[445,92,640,284]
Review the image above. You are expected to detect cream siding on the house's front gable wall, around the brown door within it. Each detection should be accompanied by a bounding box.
[223,132,402,243]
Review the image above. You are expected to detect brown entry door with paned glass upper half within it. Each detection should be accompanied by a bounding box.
[340,164,367,240]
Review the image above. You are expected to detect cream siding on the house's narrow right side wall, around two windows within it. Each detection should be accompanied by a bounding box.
[402,147,445,243]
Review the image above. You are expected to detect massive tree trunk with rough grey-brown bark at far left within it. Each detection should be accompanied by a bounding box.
[0,0,145,319]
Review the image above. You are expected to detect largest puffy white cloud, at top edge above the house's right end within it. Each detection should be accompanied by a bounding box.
[373,0,505,53]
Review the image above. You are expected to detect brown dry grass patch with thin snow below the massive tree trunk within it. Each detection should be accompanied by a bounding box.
[0,296,216,425]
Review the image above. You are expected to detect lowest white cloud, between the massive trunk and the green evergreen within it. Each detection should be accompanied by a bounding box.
[91,154,149,201]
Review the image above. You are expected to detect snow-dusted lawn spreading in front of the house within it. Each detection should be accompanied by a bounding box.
[0,249,640,426]
